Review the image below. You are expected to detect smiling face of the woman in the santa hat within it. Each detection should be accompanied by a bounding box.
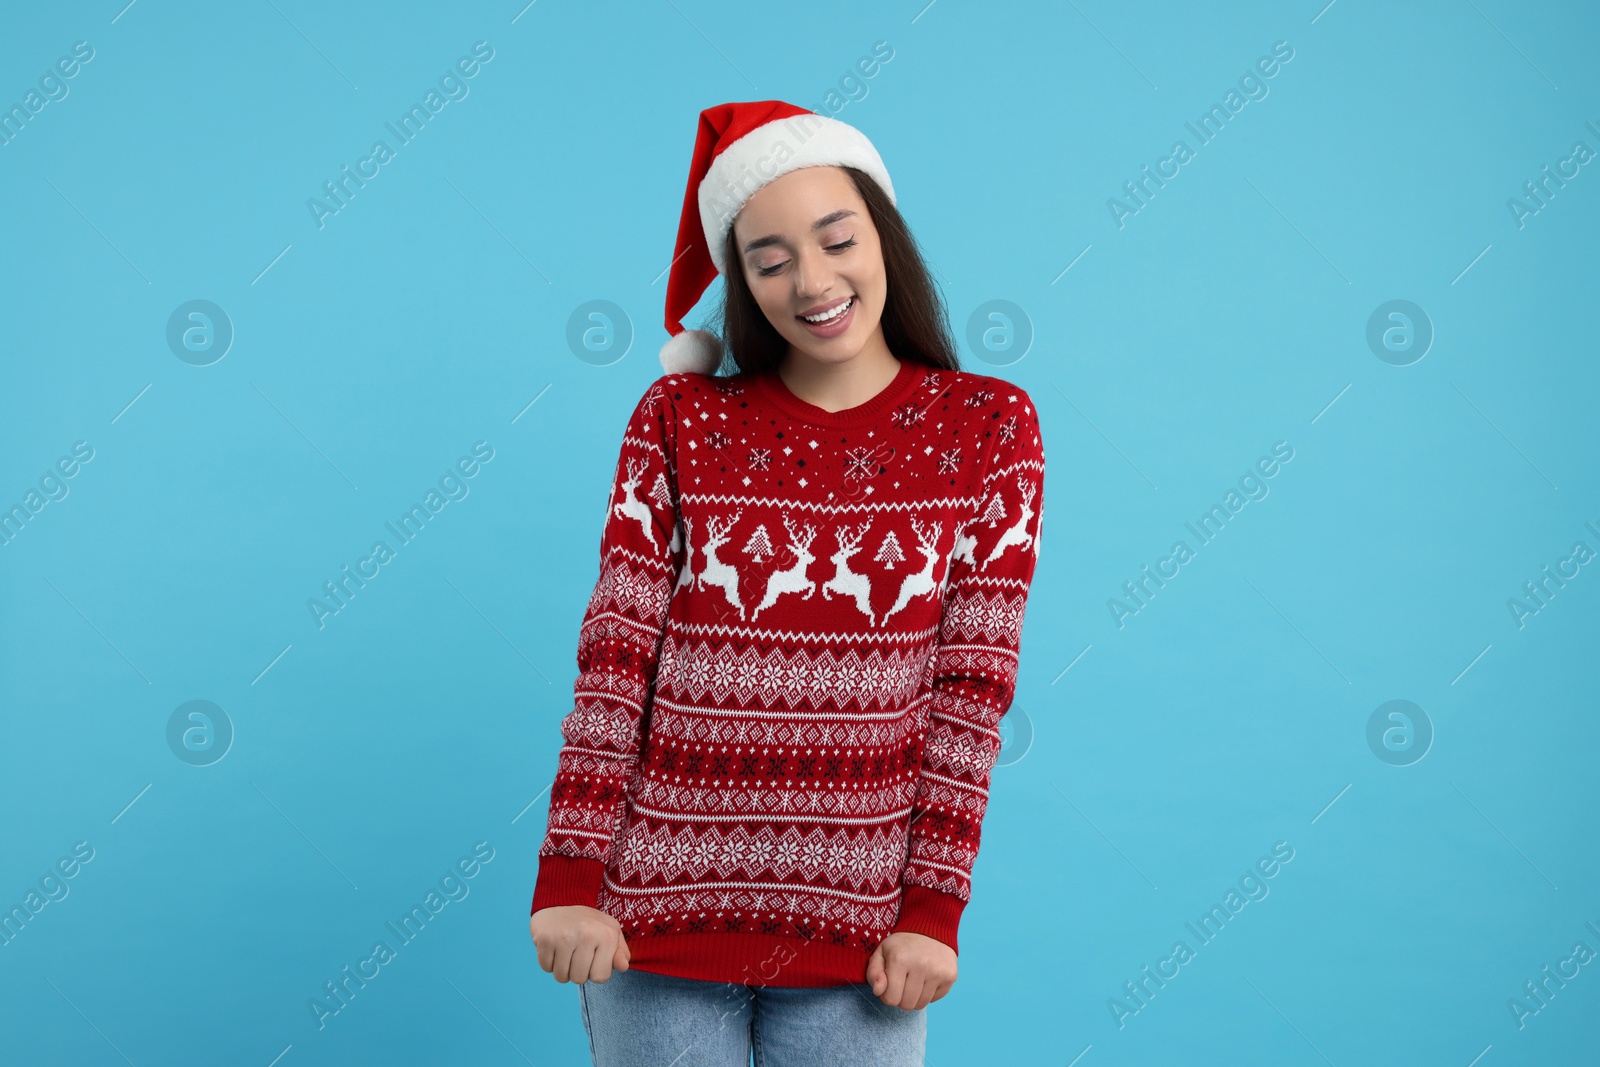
[733,166,888,363]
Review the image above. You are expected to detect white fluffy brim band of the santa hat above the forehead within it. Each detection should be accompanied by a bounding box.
[700,115,894,275]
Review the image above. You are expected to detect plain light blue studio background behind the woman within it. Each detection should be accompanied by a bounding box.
[0,0,1600,1067]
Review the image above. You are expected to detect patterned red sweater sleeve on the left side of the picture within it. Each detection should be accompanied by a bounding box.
[530,379,685,913]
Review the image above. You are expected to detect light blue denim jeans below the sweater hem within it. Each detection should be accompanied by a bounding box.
[578,969,928,1067]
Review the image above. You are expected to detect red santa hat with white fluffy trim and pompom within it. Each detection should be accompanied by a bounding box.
[661,101,894,374]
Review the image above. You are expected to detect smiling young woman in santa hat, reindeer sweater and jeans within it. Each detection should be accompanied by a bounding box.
[530,101,1045,1067]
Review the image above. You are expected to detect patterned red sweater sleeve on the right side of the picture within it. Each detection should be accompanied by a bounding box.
[894,384,1045,949]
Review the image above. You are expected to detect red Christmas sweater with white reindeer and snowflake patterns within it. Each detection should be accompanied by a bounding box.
[533,362,1045,985]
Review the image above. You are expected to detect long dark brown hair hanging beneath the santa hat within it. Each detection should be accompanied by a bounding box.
[720,166,960,374]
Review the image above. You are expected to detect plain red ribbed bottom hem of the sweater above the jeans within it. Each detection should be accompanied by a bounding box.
[627,933,872,987]
